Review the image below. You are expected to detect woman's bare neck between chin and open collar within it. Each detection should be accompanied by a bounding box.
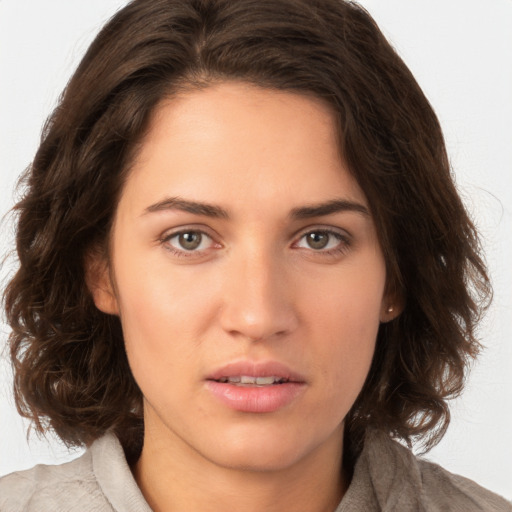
[133,424,348,512]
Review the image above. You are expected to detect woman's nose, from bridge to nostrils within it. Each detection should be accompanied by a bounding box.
[220,246,298,341]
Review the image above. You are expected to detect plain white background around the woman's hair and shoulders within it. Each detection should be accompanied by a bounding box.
[0,0,512,499]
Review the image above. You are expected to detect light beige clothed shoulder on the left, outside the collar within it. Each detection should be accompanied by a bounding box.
[0,438,113,512]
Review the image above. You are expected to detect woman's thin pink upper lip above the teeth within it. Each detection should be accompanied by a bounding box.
[206,360,306,382]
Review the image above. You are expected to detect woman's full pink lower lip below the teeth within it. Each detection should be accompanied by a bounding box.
[206,380,305,413]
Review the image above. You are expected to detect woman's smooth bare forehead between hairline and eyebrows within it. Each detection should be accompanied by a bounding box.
[125,82,365,216]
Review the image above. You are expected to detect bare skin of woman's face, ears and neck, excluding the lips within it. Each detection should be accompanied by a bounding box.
[89,82,392,512]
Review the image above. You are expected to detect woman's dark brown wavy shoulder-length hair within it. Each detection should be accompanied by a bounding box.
[4,0,490,464]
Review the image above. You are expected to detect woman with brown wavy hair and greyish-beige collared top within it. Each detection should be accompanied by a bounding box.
[0,0,510,511]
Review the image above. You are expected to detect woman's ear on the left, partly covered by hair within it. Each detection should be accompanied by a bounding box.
[84,249,119,315]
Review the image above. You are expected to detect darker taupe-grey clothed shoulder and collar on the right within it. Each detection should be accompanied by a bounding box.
[348,431,512,512]
